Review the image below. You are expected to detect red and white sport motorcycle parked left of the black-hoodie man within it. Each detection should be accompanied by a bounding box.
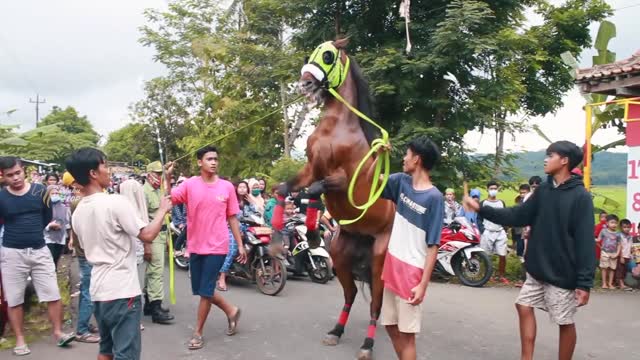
[435,217,493,287]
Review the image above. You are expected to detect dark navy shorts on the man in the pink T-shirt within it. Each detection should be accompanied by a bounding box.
[189,254,227,298]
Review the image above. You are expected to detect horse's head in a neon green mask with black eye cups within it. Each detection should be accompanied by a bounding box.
[298,39,349,104]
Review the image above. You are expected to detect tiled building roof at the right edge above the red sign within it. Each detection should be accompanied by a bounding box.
[576,50,640,97]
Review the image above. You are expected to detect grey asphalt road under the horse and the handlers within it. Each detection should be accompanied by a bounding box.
[20,262,640,360]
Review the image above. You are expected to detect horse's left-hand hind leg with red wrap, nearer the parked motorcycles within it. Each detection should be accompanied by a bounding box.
[323,239,358,346]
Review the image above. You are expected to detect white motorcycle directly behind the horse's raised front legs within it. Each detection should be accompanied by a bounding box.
[285,214,332,284]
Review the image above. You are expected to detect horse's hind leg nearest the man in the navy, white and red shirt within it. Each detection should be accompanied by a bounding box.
[358,230,390,360]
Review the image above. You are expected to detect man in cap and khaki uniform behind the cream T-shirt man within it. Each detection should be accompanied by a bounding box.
[142,161,174,324]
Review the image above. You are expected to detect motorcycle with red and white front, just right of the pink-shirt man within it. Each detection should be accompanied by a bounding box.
[229,214,287,296]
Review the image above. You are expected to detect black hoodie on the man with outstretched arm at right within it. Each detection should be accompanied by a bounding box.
[480,176,596,291]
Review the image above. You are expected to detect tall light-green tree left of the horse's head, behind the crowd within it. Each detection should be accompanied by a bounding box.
[140,0,306,176]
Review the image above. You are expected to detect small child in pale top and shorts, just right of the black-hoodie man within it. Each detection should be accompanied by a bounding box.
[598,214,622,289]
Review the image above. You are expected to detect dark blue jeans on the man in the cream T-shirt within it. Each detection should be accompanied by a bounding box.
[93,296,142,360]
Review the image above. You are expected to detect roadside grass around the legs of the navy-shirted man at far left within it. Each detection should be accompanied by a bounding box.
[0,256,72,350]
